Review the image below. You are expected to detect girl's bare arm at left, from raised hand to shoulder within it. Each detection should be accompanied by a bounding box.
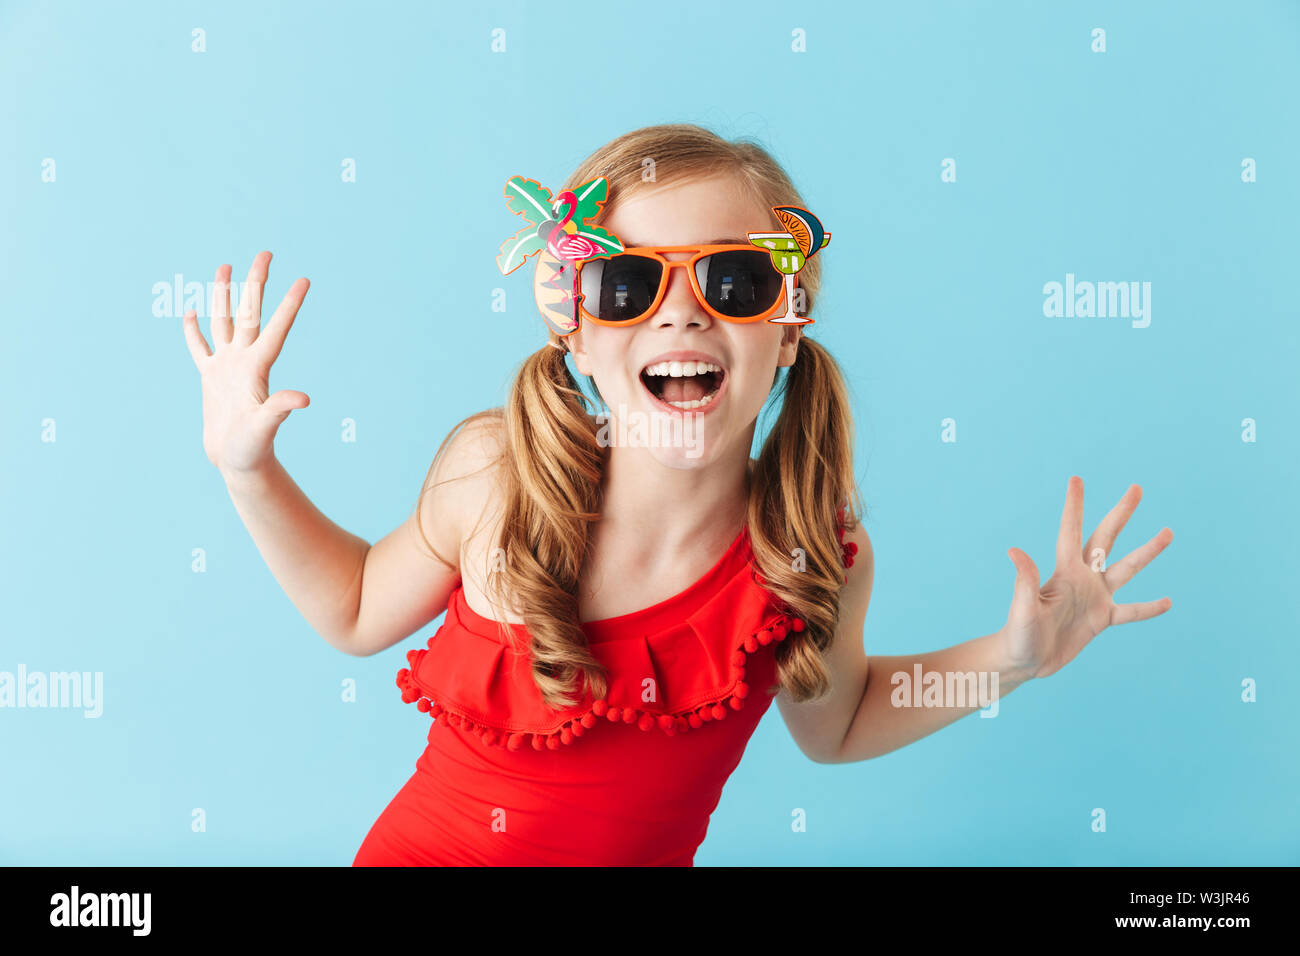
[185,252,481,656]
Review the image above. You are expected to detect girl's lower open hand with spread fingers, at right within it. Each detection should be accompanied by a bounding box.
[1001,477,1174,678]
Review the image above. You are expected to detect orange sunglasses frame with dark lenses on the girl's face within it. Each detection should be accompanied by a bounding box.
[577,245,793,325]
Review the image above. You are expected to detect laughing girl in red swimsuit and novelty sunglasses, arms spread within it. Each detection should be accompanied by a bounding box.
[185,125,1173,866]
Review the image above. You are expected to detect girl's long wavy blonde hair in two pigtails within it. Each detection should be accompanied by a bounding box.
[416,124,862,709]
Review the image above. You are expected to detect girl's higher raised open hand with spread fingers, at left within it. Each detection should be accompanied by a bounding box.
[185,252,311,475]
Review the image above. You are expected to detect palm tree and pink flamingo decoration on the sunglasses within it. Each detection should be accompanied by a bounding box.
[497,176,623,336]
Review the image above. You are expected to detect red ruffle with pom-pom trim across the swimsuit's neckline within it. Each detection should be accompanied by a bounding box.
[397,531,805,750]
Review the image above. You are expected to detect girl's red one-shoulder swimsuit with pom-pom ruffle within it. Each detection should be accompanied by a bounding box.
[352,528,852,866]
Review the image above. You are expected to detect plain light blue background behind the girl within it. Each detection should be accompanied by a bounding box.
[0,0,1300,865]
